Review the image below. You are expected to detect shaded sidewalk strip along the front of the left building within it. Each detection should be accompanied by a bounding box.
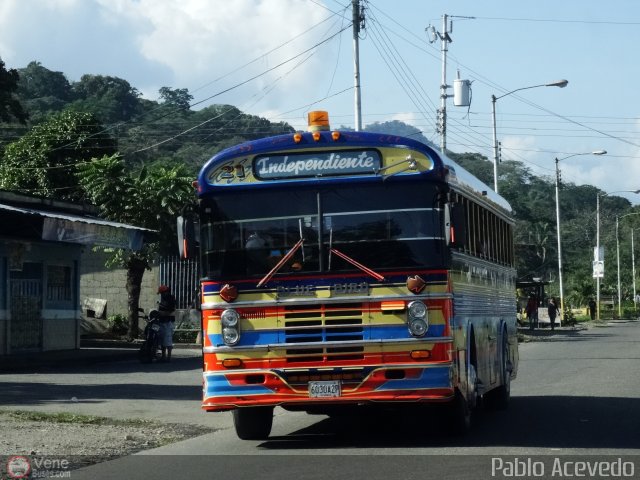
[0,339,200,373]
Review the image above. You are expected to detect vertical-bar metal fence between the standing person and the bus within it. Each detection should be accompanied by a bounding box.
[159,257,200,309]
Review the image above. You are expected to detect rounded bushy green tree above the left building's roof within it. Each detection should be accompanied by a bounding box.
[0,111,116,200]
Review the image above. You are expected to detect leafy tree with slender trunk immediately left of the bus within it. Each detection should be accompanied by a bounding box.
[77,155,194,338]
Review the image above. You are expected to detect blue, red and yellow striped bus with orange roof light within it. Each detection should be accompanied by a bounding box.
[178,112,518,439]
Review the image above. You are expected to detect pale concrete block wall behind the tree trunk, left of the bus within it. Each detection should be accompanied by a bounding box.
[80,248,159,323]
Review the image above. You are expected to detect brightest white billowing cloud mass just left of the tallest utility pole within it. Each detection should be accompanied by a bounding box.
[94,0,336,107]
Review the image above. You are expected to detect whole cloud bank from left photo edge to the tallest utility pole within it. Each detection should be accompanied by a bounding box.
[0,0,340,111]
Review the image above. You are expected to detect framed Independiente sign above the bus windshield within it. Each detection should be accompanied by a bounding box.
[253,150,381,180]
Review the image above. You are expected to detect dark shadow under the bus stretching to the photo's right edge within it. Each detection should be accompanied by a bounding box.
[260,396,640,450]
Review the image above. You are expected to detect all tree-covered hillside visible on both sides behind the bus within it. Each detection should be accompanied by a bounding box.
[0,60,640,303]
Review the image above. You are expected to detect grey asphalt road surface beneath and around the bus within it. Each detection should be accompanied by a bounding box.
[0,321,640,480]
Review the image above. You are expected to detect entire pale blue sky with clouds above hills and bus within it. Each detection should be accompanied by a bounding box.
[0,0,640,204]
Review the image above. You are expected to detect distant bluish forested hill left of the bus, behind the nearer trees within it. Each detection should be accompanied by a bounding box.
[0,62,293,173]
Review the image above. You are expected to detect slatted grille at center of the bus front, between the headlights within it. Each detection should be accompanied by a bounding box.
[282,303,364,363]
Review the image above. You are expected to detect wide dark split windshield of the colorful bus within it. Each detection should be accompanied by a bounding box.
[200,182,446,280]
